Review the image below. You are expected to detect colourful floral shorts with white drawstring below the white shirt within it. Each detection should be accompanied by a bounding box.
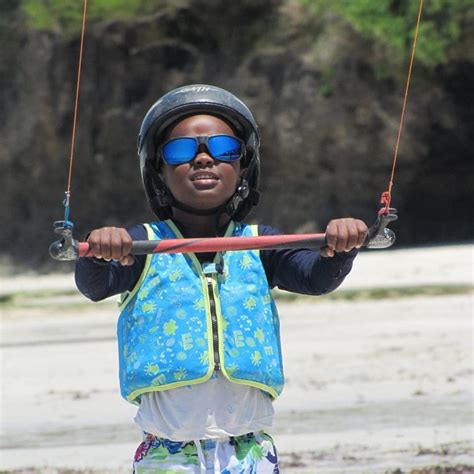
[133,432,280,474]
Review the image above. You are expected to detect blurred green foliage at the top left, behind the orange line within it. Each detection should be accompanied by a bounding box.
[22,0,172,31]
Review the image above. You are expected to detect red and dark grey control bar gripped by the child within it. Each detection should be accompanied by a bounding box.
[49,208,398,261]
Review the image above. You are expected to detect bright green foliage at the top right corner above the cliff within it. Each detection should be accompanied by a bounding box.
[301,0,474,67]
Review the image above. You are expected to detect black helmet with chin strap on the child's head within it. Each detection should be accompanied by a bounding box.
[138,84,260,220]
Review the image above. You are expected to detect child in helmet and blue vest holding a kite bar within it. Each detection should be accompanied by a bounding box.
[76,85,367,474]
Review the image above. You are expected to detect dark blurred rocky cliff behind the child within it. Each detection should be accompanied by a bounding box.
[0,0,474,264]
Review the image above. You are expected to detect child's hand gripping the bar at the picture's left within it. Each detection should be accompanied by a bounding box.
[87,227,134,266]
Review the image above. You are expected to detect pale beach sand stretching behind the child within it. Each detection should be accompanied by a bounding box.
[0,245,474,474]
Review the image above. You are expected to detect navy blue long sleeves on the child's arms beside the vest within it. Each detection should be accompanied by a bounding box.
[75,224,357,301]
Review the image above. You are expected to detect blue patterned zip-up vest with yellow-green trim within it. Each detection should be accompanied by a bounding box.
[117,220,284,403]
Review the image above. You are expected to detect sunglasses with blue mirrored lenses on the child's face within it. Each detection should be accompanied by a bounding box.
[161,135,245,166]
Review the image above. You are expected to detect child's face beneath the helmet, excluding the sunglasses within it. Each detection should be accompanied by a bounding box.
[161,115,240,209]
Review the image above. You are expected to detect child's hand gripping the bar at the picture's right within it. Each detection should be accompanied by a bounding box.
[321,217,368,257]
